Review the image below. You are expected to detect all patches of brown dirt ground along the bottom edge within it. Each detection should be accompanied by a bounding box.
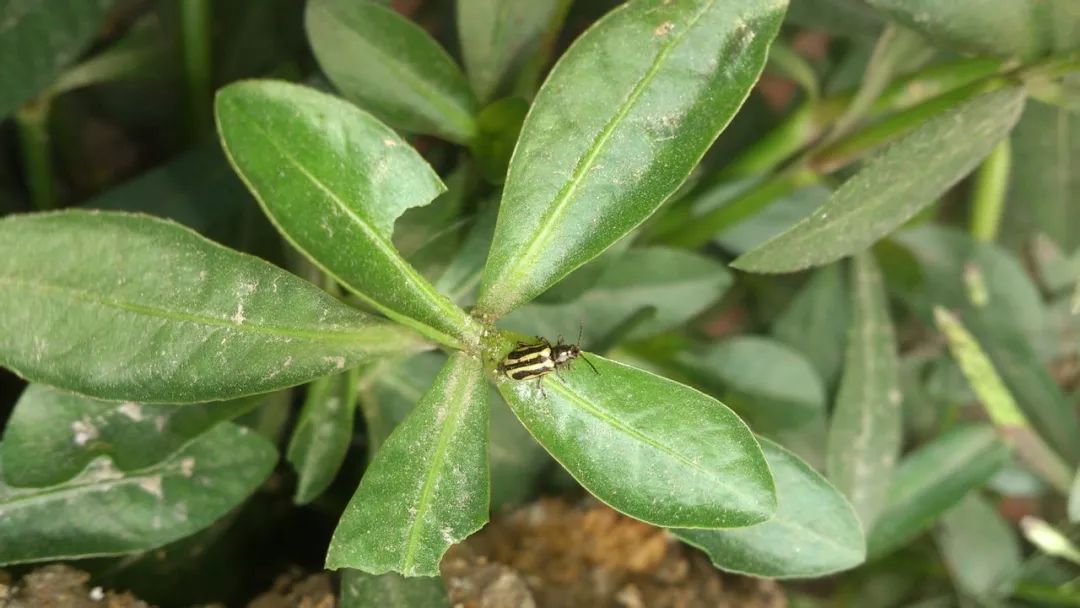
[0,499,787,608]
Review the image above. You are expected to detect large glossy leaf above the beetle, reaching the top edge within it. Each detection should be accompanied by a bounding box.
[477,0,786,317]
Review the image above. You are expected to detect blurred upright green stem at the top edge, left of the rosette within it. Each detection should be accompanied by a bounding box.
[179,0,213,139]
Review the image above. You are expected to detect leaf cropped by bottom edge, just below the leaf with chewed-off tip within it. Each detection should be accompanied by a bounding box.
[340,569,450,608]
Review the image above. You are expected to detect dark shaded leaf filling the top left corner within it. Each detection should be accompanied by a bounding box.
[0,0,113,119]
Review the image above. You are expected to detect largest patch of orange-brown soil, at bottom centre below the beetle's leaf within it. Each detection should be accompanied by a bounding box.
[442,499,787,608]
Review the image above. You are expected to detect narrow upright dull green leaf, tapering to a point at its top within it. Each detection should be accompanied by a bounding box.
[825,252,903,530]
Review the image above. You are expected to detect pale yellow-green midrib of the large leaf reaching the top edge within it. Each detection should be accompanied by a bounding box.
[494,0,716,298]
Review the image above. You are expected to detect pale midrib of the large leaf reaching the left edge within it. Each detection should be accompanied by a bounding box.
[0,276,364,342]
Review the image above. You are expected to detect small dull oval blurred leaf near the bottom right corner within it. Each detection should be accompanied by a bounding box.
[936,494,1022,599]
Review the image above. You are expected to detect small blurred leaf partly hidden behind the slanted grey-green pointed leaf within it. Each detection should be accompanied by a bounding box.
[713,185,832,255]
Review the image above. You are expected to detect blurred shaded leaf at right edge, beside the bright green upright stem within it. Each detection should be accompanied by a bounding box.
[1001,102,1080,252]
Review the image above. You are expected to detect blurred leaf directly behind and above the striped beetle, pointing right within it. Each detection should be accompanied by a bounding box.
[500,247,733,343]
